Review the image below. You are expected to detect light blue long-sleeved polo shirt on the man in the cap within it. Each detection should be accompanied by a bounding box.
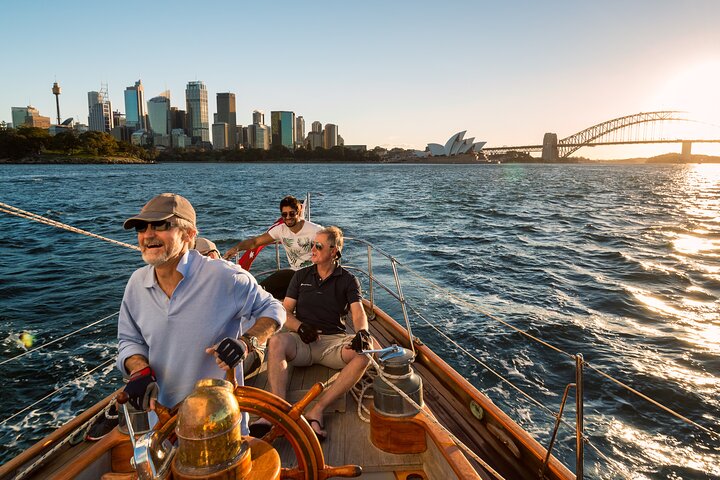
[117,250,285,407]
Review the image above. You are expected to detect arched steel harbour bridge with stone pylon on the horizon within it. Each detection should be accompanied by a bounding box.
[482,110,720,161]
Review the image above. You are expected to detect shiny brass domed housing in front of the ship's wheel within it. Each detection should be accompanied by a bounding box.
[172,378,250,478]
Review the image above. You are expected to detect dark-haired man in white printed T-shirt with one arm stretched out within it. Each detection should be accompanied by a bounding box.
[224,195,322,300]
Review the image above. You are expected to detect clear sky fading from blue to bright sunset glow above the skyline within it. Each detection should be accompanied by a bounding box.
[0,0,720,158]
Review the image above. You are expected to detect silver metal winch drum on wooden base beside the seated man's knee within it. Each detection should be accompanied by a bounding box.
[373,345,423,417]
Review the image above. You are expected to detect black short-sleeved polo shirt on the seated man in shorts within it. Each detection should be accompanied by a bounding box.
[285,265,362,335]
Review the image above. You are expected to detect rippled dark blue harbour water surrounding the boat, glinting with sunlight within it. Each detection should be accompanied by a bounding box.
[0,163,720,479]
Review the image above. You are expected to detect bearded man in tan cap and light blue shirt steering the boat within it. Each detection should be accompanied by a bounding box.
[117,193,285,422]
